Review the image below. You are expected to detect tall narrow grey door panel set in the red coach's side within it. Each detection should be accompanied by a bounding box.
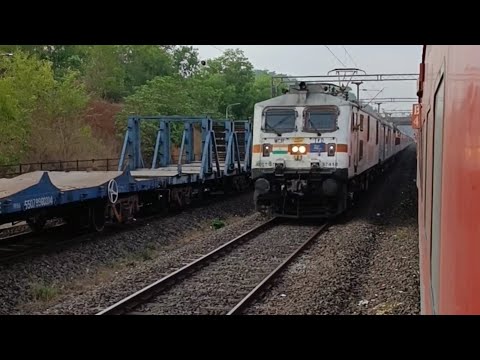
[430,79,445,313]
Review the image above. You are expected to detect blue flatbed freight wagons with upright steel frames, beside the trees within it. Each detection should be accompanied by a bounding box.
[0,117,251,232]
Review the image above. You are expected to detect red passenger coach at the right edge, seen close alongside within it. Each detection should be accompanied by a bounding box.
[412,45,480,314]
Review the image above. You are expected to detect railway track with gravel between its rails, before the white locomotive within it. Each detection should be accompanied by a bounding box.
[97,218,328,315]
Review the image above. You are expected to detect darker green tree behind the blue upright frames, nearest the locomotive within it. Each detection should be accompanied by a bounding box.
[113,47,278,157]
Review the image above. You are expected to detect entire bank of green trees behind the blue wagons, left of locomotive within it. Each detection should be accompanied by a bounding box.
[0,45,284,167]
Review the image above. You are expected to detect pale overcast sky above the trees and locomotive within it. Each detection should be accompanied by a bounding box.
[192,45,422,110]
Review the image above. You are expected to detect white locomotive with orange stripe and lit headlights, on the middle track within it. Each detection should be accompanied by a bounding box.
[252,82,411,218]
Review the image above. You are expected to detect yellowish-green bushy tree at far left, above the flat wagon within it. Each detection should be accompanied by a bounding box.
[0,50,102,164]
